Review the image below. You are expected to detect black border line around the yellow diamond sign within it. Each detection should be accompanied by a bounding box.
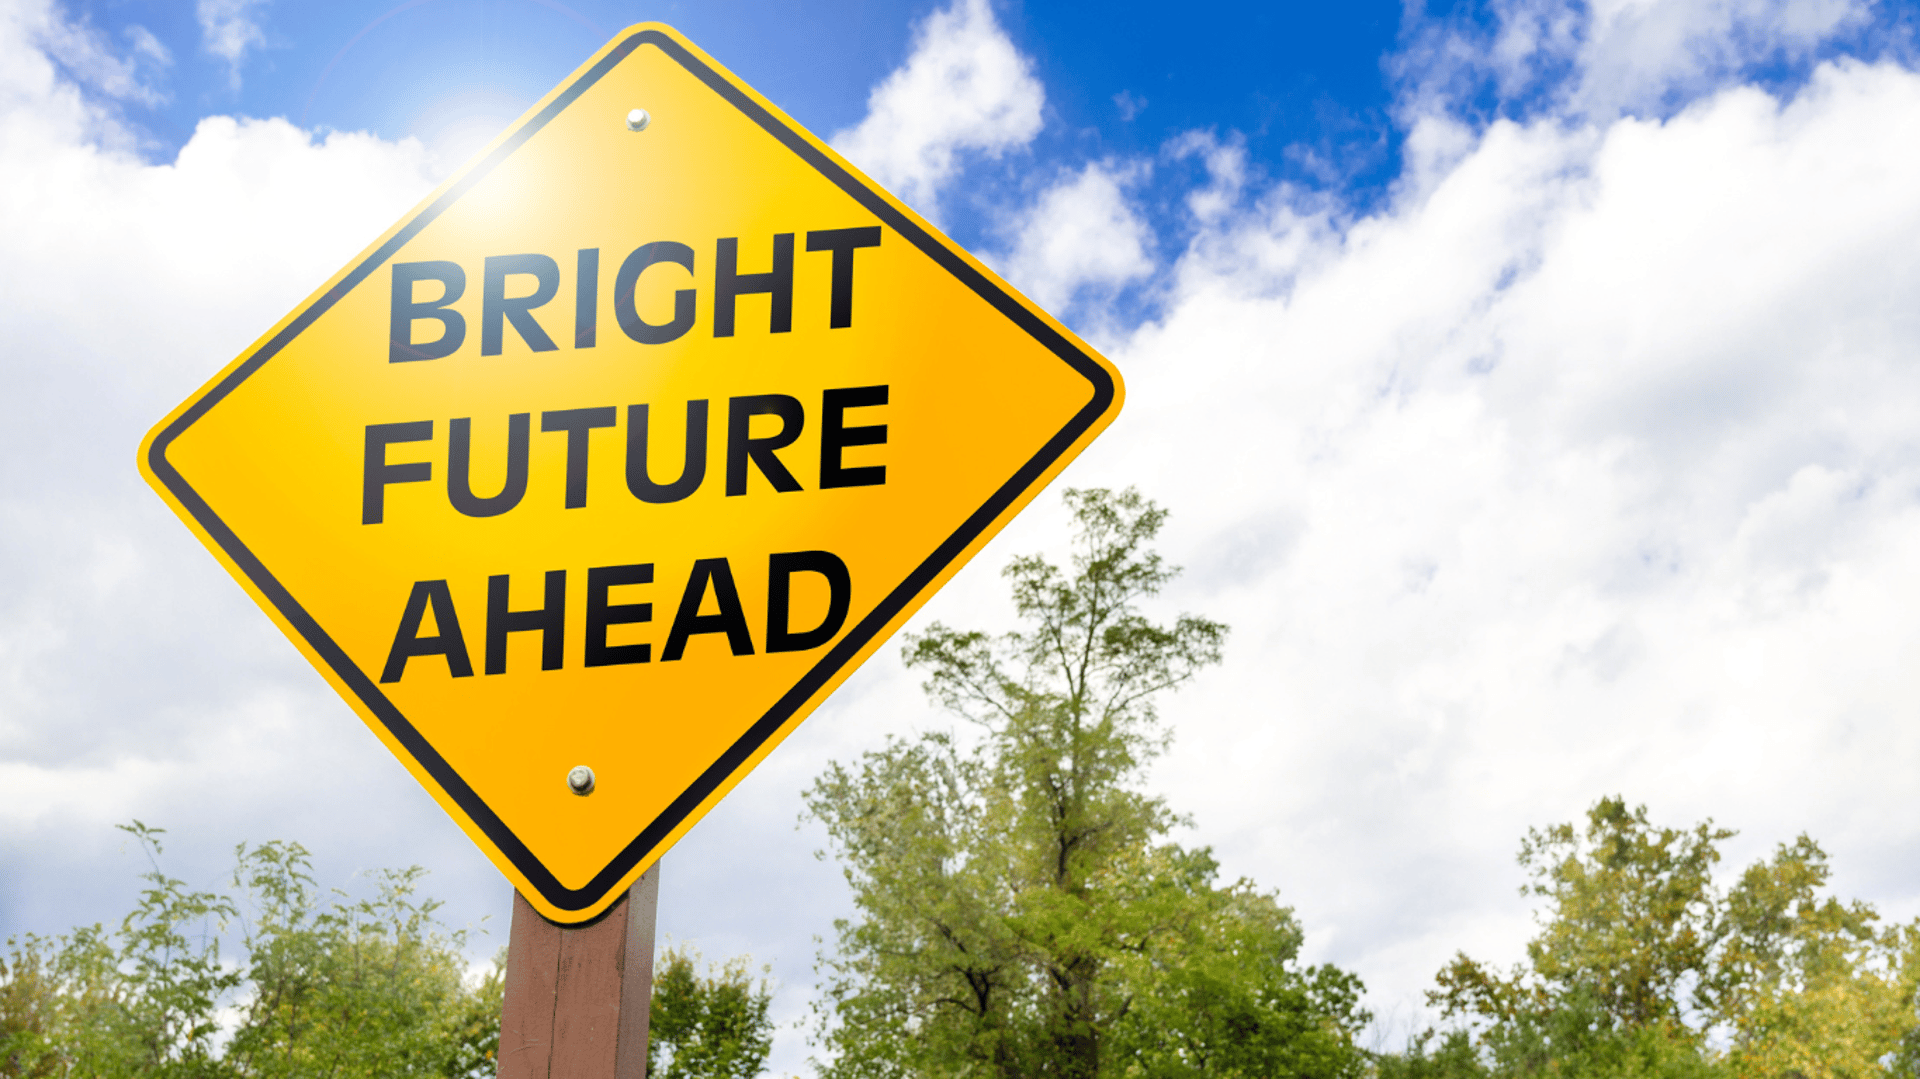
[148,31,1116,910]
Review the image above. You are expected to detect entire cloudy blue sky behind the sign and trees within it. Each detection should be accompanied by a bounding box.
[0,0,1920,1073]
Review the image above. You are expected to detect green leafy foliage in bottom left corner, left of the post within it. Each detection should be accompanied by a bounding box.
[0,822,501,1079]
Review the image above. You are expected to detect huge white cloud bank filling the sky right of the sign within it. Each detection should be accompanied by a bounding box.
[1073,61,1920,1016]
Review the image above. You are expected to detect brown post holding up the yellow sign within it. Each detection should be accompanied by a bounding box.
[499,862,660,1079]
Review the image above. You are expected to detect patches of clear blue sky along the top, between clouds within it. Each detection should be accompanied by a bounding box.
[56,0,1920,242]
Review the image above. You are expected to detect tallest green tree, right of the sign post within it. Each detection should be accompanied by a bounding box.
[806,490,1365,1079]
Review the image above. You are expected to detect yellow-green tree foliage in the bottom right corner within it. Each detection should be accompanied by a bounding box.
[1377,799,1920,1079]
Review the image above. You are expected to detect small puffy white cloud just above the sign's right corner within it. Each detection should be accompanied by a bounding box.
[1006,163,1154,309]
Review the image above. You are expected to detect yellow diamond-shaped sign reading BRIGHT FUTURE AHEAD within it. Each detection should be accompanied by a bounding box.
[140,25,1121,923]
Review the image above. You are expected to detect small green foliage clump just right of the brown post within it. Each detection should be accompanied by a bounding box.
[647,948,774,1079]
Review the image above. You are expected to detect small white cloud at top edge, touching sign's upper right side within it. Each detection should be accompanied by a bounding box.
[831,0,1046,217]
